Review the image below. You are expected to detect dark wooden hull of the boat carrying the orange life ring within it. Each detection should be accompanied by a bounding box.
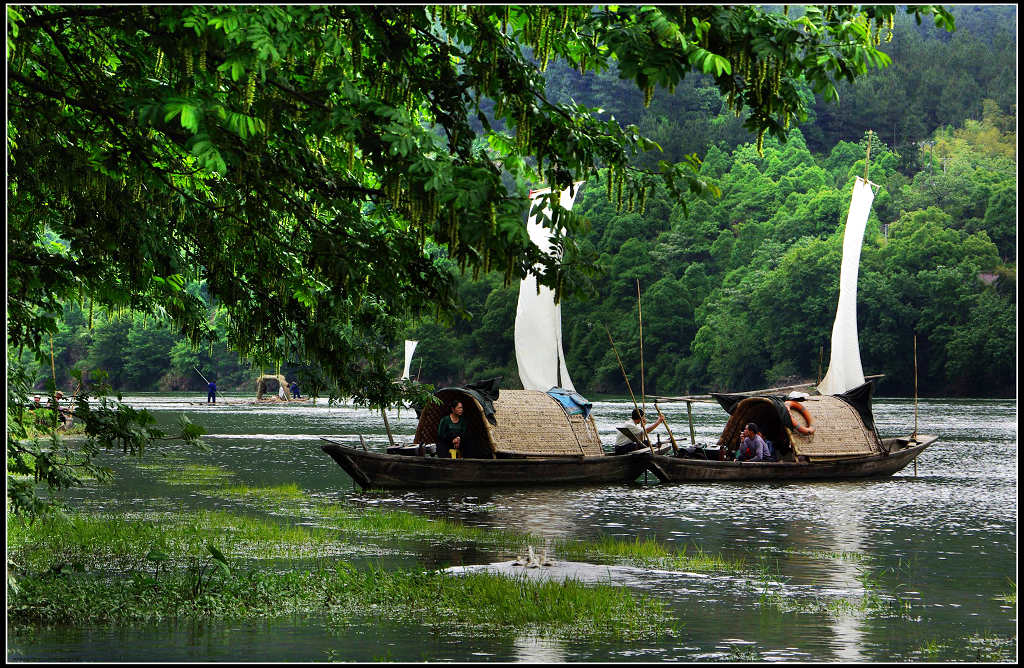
[647,435,938,483]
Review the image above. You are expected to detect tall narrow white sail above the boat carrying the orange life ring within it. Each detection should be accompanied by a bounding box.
[818,176,874,394]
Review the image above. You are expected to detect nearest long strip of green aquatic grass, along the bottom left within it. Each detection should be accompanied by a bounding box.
[8,562,678,639]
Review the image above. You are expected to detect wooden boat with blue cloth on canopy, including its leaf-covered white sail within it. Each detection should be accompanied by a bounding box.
[322,185,675,488]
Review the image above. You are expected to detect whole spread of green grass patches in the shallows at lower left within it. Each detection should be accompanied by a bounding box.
[7,495,704,639]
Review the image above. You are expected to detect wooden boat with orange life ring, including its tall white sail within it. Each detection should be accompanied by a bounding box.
[648,177,938,482]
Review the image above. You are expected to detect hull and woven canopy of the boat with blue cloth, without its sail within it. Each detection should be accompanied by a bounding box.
[321,387,668,488]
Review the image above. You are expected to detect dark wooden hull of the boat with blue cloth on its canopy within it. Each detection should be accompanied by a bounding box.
[321,442,664,489]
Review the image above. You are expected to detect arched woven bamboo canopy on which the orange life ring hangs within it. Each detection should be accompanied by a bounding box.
[718,394,882,461]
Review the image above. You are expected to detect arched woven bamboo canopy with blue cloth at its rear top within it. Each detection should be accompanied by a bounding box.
[414,387,604,458]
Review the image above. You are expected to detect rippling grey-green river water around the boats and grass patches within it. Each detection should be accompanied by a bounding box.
[8,394,1018,662]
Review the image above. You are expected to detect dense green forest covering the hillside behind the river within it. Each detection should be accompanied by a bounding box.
[26,6,1017,396]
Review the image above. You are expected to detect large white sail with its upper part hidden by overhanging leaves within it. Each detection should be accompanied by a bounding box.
[515,181,583,391]
